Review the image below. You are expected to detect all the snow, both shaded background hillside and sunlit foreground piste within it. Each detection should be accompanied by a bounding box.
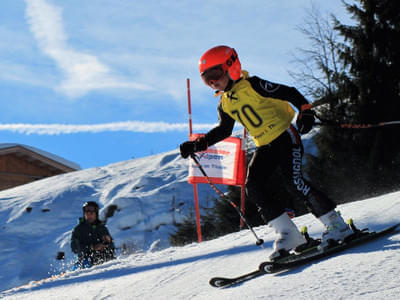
[0,144,400,299]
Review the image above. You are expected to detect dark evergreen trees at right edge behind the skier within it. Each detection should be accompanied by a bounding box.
[308,0,400,202]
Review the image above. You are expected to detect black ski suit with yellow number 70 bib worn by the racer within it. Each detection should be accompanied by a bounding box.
[205,71,336,223]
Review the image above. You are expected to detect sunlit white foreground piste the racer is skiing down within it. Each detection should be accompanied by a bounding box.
[0,192,400,299]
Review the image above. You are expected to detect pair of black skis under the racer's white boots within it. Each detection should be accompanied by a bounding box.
[209,223,400,288]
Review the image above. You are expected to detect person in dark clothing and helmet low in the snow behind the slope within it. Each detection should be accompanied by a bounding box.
[71,201,115,268]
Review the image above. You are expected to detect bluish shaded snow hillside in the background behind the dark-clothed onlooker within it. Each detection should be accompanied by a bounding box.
[0,150,219,291]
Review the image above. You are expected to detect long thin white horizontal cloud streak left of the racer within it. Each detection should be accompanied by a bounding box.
[0,121,216,135]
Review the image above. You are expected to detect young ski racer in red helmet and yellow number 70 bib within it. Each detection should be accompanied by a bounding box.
[180,46,353,260]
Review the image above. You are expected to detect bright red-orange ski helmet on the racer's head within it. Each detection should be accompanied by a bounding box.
[199,46,242,80]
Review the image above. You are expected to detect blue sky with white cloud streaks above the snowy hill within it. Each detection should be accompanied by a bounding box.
[0,0,352,168]
